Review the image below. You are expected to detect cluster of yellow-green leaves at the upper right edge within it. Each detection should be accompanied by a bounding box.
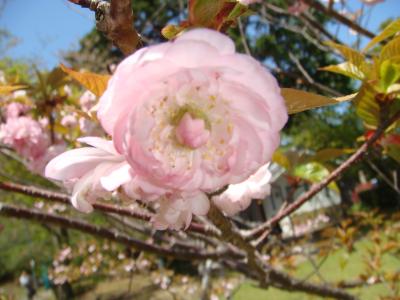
[323,19,400,128]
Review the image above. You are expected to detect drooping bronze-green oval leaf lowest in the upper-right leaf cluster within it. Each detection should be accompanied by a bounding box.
[354,83,380,128]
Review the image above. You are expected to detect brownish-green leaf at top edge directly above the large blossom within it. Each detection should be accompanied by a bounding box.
[189,0,225,27]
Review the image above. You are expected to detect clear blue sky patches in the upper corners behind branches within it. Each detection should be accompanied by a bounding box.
[0,0,400,68]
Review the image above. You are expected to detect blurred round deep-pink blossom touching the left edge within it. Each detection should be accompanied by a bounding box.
[0,116,50,160]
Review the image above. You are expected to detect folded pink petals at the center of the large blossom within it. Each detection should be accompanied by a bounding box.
[175,112,210,149]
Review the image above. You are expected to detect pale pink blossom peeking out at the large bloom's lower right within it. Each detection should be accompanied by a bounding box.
[213,164,271,216]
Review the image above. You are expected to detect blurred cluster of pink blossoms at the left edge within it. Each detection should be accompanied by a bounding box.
[0,91,65,174]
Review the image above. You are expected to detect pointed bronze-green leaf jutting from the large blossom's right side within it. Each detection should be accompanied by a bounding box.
[281,88,356,114]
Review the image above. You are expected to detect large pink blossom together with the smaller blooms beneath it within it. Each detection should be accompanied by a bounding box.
[46,29,288,230]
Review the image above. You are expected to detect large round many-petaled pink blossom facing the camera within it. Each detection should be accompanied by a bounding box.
[98,29,287,197]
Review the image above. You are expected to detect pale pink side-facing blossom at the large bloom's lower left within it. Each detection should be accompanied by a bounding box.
[45,137,132,212]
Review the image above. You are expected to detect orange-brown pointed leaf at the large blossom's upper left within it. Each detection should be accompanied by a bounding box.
[60,64,111,97]
